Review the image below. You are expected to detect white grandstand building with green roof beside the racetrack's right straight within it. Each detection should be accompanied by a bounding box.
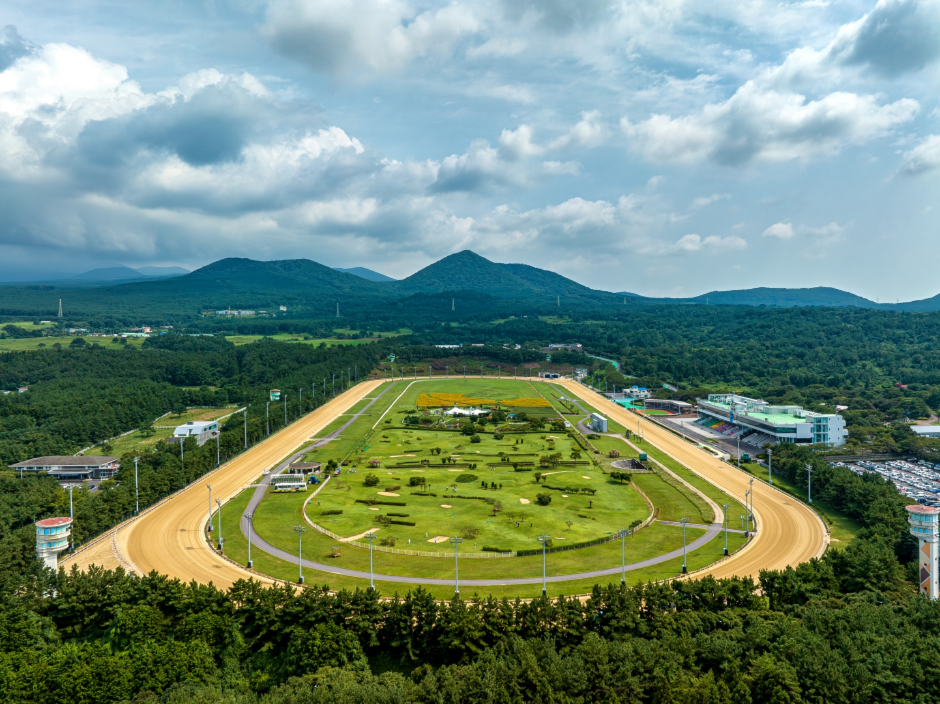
[696,394,848,447]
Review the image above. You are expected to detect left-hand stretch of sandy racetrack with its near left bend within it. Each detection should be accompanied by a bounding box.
[63,381,382,587]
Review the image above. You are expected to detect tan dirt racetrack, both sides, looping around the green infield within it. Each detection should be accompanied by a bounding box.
[61,379,828,588]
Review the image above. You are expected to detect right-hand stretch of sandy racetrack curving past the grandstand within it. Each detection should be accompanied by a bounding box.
[553,379,829,579]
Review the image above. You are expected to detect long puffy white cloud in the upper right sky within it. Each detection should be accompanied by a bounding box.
[621,81,919,166]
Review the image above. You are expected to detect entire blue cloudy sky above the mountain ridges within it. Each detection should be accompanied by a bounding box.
[0,0,940,302]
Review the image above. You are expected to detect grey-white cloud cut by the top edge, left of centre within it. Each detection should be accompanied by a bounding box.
[262,0,480,74]
